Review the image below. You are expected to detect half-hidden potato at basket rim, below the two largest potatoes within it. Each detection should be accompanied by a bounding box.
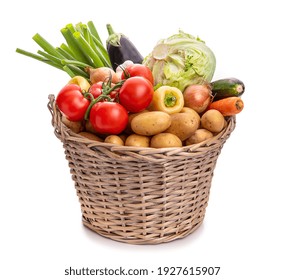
[150,132,182,148]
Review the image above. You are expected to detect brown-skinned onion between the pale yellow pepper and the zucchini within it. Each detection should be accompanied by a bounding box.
[183,84,213,114]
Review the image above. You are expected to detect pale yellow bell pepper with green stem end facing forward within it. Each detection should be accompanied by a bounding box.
[150,86,184,114]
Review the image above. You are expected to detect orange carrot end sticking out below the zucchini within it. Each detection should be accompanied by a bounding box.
[208,96,244,116]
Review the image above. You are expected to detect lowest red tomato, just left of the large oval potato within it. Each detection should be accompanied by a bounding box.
[89,101,128,134]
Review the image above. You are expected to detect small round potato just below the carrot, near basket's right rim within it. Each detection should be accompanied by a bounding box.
[201,109,225,133]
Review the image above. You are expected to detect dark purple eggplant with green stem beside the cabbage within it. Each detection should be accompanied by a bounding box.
[107,24,143,71]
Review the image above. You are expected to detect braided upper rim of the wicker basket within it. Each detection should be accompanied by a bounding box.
[48,94,236,155]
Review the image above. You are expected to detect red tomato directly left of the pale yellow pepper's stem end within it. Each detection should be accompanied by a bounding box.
[119,77,153,113]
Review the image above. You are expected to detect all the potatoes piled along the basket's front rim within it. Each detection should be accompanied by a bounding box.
[62,107,226,148]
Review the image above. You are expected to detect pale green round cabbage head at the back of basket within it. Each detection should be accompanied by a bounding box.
[143,31,216,92]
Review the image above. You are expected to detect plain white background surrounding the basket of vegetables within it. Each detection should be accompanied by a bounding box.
[0,0,285,280]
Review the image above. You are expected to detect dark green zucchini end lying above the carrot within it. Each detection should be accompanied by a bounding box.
[210,78,245,100]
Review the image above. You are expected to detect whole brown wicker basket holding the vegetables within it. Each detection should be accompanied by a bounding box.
[48,95,235,244]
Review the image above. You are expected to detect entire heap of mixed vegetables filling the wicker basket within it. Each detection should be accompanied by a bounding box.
[16,21,245,148]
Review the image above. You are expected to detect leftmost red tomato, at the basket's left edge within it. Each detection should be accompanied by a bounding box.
[56,84,90,121]
